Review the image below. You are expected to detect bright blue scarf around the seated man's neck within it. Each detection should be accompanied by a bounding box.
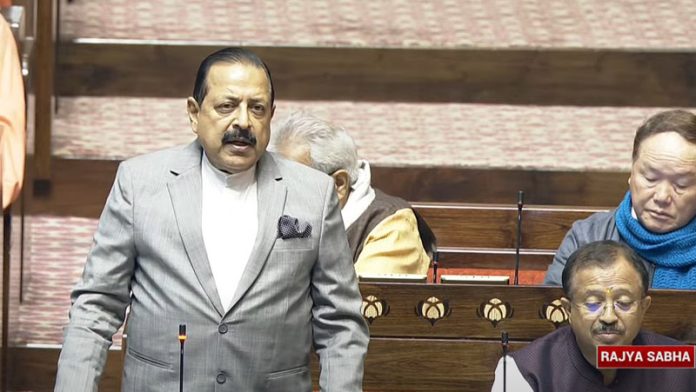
[614,192,696,290]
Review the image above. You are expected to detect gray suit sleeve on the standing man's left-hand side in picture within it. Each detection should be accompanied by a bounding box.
[55,164,135,392]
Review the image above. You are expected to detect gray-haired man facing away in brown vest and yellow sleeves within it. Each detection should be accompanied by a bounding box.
[271,113,435,275]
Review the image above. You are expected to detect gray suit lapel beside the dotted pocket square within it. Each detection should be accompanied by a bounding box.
[230,152,287,316]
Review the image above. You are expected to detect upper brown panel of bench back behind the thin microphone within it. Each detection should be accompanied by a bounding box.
[413,203,604,249]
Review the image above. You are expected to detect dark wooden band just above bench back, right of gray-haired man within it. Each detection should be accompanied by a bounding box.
[372,166,629,207]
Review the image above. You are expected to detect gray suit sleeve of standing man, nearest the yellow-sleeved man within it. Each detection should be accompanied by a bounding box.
[312,182,369,392]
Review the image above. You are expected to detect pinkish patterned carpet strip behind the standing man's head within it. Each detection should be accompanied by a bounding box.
[54,97,684,171]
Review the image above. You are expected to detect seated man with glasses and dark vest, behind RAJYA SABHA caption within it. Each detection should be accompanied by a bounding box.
[493,240,696,392]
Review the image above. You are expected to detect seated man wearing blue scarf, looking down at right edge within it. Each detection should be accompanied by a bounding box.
[544,110,696,290]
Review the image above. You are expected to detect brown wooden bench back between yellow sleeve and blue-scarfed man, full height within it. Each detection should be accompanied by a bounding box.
[412,203,609,284]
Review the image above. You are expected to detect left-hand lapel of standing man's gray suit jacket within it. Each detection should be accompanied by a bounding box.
[167,142,224,317]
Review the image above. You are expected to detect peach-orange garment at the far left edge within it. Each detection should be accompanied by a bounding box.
[0,16,26,209]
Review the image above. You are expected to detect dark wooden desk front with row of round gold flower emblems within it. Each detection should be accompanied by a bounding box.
[324,283,696,391]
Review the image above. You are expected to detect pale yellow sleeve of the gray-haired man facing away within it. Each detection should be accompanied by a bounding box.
[355,208,430,275]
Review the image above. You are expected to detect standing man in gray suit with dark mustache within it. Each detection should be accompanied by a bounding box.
[55,48,369,392]
